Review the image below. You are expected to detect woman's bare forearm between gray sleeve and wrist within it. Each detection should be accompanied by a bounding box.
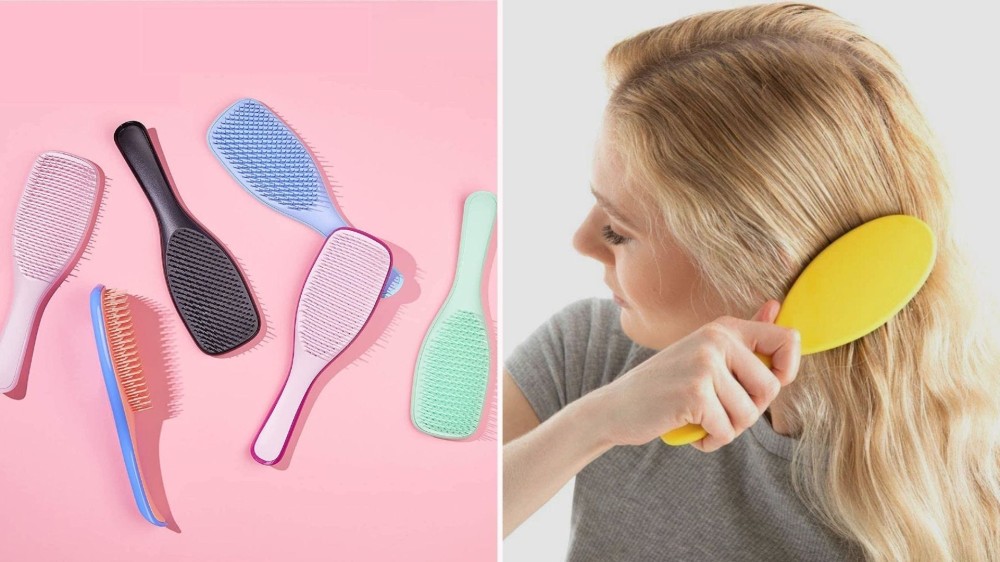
[503,396,612,537]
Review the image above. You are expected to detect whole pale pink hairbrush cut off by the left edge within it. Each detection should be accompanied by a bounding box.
[0,152,104,392]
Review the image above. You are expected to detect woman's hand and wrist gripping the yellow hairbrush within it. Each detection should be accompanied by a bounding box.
[581,300,801,452]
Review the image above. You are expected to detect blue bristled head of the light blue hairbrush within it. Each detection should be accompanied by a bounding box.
[210,100,331,211]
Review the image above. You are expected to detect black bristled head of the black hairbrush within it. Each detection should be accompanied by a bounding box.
[163,228,260,355]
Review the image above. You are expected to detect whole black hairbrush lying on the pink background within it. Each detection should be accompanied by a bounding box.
[115,121,260,355]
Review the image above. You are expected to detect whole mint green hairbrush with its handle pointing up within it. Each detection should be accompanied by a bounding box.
[410,191,497,439]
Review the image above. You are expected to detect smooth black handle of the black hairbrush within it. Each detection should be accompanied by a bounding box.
[115,121,201,236]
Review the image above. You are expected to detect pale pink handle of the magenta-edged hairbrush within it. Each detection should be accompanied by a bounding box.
[250,350,327,465]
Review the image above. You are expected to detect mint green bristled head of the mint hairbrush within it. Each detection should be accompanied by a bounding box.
[412,308,490,439]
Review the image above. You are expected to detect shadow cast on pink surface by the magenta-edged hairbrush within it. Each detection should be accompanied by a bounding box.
[261,243,420,470]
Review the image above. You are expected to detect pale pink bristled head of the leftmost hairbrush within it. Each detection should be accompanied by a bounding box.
[14,152,100,282]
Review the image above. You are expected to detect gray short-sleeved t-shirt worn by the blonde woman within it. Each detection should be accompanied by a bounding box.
[505,299,861,562]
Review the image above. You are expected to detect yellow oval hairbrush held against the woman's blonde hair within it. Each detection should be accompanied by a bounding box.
[660,215,936,445]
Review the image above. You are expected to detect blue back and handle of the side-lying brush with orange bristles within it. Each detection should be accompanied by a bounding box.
[90,285,167,527]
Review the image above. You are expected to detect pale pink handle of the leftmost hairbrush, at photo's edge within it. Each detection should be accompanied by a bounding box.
[0,274,51,393]
